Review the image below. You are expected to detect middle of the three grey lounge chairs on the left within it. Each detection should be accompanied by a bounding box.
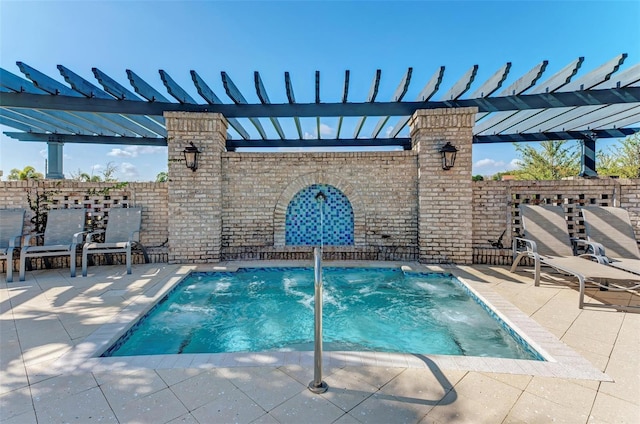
[20,209,86,281]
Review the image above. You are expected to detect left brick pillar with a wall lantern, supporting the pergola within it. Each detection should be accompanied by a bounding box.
[164,112,227,263]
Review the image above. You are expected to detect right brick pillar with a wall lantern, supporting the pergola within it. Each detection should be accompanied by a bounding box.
[409,107,478,264]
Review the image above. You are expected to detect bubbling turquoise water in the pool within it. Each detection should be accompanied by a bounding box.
[103,268,542,359]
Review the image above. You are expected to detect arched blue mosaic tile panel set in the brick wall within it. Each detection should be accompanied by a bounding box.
[285,184,354,246]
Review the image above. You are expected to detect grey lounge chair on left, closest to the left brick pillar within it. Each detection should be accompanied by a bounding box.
[82,208,142,277]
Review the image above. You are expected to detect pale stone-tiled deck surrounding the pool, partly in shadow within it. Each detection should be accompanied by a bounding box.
[0,262,640,424]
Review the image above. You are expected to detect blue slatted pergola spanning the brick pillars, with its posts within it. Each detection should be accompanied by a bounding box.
[0,54,640,178]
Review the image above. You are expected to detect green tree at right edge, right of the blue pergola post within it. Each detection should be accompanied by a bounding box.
[597,133,640,178]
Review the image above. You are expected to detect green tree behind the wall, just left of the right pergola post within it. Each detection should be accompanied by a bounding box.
[512,141,580,180]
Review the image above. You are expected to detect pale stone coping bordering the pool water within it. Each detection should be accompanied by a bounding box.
[53,261,613,381]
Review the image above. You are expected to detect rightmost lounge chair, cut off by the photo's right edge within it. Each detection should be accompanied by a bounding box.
[581,206,640,274]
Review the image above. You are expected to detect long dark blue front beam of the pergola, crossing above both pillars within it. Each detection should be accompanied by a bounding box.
[0,87,640,118]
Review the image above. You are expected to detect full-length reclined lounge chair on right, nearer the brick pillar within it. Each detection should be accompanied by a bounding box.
[511,205,640,310]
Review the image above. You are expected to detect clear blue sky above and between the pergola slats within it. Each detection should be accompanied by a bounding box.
[0,0,640,181]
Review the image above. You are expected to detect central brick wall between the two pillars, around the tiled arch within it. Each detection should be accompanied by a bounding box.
[222,151,417,260]
